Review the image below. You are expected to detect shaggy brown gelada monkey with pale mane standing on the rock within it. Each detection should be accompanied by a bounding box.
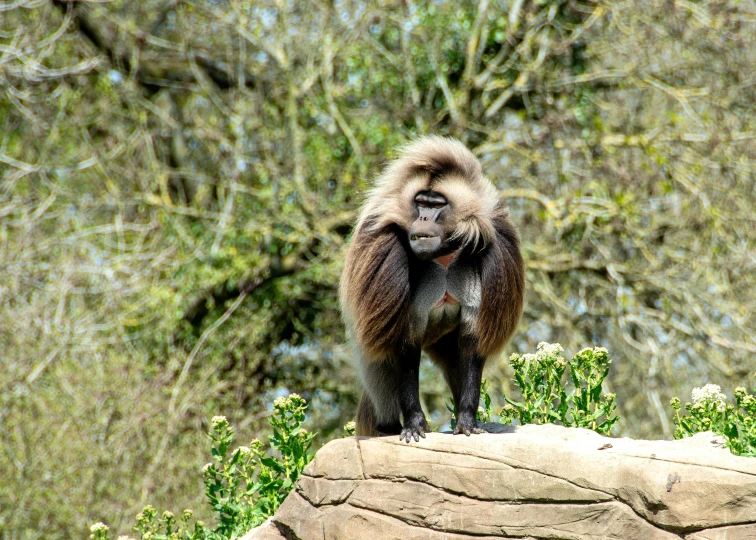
[339,136,525,443]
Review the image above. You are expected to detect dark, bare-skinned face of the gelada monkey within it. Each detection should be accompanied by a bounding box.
[409,190,458,261]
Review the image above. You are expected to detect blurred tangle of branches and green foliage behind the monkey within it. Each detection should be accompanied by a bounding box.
[0,0,756,540]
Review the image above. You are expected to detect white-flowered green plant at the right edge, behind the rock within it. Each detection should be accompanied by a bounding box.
[670,384,756,457]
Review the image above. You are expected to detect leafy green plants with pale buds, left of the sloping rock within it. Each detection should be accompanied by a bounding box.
[90,394,315,540]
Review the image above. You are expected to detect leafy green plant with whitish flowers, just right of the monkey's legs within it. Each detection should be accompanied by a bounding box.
[499,342,619,435]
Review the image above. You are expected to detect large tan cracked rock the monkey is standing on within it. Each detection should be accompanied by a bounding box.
[244,425,756,540]
